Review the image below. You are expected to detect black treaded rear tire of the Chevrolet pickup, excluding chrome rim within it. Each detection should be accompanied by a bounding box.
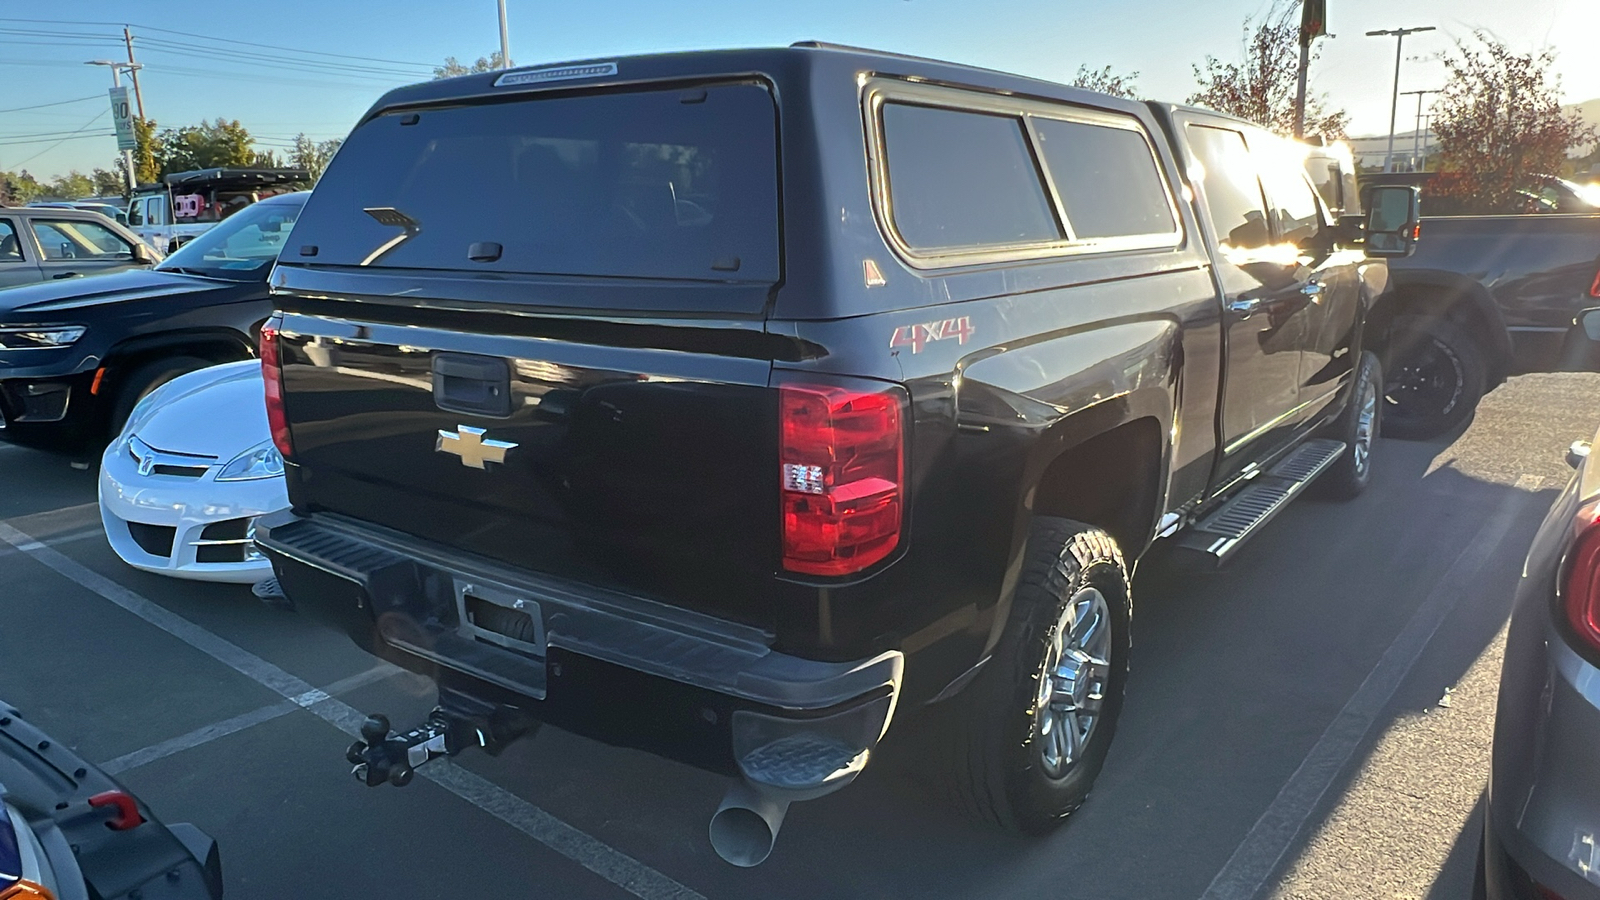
[925,517,1133,834]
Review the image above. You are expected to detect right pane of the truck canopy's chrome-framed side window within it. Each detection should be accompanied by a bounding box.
[1034,119,1178,239]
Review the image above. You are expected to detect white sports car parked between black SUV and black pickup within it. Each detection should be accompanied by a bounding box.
[99,360,290,585]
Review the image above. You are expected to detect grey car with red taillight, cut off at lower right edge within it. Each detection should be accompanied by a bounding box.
[1477,309,1600,900]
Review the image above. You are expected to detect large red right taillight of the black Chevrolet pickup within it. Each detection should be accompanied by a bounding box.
[778,377,906,575]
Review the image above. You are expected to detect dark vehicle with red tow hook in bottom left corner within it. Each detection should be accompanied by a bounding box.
[0,703,222,900]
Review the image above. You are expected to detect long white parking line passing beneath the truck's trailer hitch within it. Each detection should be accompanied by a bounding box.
[0,522,706,900]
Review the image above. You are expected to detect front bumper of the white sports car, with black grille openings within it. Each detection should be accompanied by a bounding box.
[99,439,290,585]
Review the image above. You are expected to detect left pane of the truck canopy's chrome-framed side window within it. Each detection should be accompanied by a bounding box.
[883,102,1062,250]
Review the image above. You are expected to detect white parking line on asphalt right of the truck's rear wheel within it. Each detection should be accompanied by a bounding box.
[1200,476,1544,900]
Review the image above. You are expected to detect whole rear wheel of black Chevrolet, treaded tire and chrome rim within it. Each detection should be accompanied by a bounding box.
[930,517,1131,833]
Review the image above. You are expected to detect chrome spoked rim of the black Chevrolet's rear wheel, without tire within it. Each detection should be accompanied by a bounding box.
[1034,588,1112,778]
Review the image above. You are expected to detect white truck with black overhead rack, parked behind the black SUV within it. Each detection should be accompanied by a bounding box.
[128,168,310,253]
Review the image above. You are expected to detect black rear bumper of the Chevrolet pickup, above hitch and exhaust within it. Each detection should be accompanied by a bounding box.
[256,511,904,784]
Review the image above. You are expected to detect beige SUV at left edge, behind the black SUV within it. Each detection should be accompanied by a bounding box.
[0,207,162,288]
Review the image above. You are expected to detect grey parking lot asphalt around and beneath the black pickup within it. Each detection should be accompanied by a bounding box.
[0,368,1600,900]
